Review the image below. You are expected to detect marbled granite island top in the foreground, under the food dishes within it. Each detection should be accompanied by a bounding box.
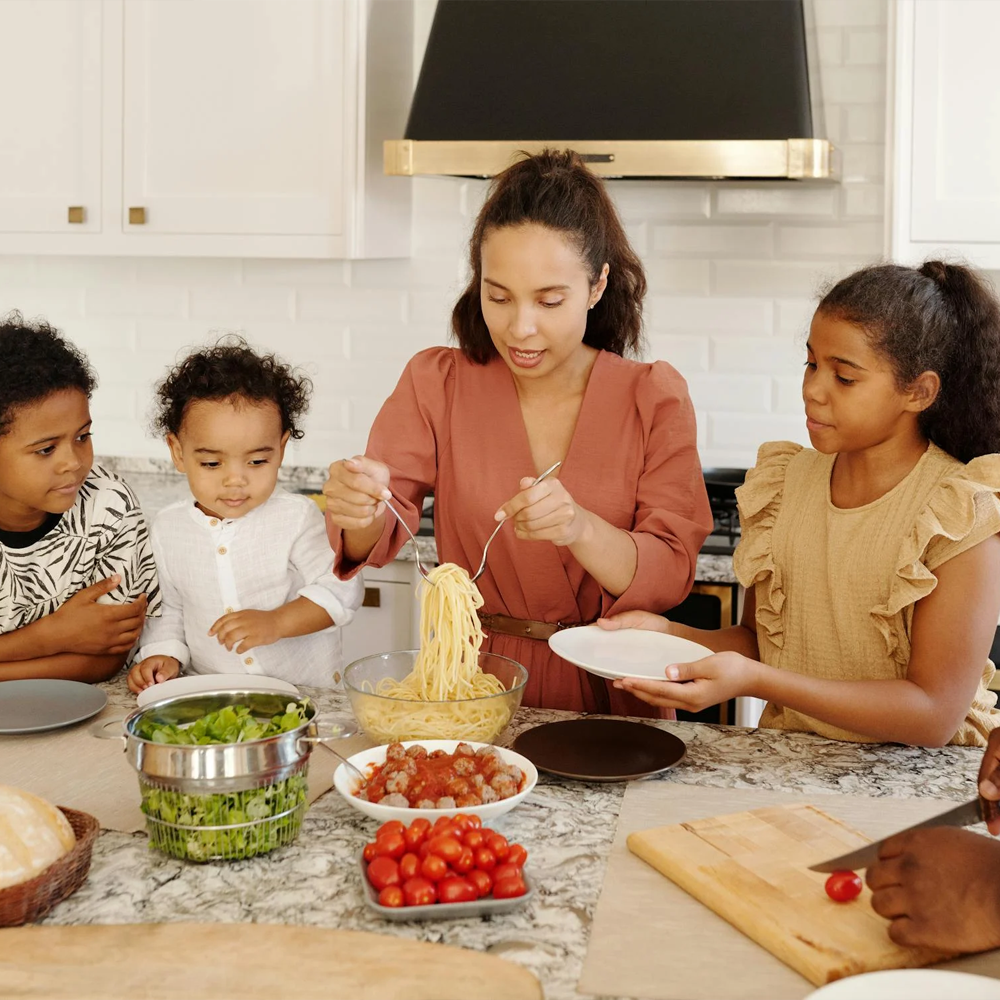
[45,678,982,1000]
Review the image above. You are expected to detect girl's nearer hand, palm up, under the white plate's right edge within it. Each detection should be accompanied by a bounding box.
[615,652,760,712]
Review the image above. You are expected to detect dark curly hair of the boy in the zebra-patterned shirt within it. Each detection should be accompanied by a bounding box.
[0,310,97,437]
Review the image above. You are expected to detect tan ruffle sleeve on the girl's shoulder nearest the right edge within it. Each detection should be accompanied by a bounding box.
[871,446,1000,663]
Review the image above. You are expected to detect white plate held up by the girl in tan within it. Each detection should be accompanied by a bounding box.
[549,625,712,681]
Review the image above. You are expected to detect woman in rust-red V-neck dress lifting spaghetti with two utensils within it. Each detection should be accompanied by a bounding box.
[323,151,712,715]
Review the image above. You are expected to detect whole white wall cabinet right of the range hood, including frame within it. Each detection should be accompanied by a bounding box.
[892,0,1000,268]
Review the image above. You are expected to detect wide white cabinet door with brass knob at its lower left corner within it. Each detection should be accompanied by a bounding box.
[122,0,357,235]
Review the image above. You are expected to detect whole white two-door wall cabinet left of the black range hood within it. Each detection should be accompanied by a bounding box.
[0,0,412,258]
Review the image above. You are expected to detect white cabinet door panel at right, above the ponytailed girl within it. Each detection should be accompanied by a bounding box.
[903,0,1000,250]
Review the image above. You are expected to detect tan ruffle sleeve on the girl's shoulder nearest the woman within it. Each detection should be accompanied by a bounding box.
[733,441,802,648]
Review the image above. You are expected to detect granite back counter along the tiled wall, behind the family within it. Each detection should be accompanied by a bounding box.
[96,456,737,584]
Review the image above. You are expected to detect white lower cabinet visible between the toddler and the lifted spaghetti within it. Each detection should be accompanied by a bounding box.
[343,559,420,666]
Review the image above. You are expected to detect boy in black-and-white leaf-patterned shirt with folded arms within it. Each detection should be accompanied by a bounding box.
[0,312,159,682]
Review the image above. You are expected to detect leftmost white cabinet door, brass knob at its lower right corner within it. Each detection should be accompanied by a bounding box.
[0,0,101,233]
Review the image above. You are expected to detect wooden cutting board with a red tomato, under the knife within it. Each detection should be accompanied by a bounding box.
[626,803,949,986]
